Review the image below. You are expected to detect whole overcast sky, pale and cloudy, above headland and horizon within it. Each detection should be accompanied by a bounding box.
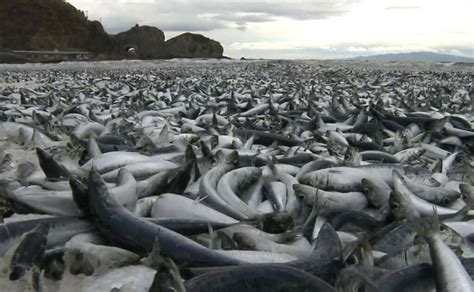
[68,0,474,59]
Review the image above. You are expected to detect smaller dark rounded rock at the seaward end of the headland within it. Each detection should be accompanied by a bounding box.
[165,33,224,58]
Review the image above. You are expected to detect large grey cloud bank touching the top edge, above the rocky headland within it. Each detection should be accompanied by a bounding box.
[70,0,357,33]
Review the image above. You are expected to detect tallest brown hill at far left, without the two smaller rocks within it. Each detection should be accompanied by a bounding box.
[0,0,110,52]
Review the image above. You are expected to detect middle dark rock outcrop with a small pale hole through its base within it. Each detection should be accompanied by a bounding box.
[114,25,165,59]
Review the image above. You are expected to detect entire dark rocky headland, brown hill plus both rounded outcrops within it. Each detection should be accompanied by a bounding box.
[0,0,223,62]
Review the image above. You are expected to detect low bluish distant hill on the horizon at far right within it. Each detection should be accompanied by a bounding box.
[353,52,474,63]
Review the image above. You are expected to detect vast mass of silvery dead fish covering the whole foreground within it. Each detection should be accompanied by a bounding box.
[0,61,474,292]
